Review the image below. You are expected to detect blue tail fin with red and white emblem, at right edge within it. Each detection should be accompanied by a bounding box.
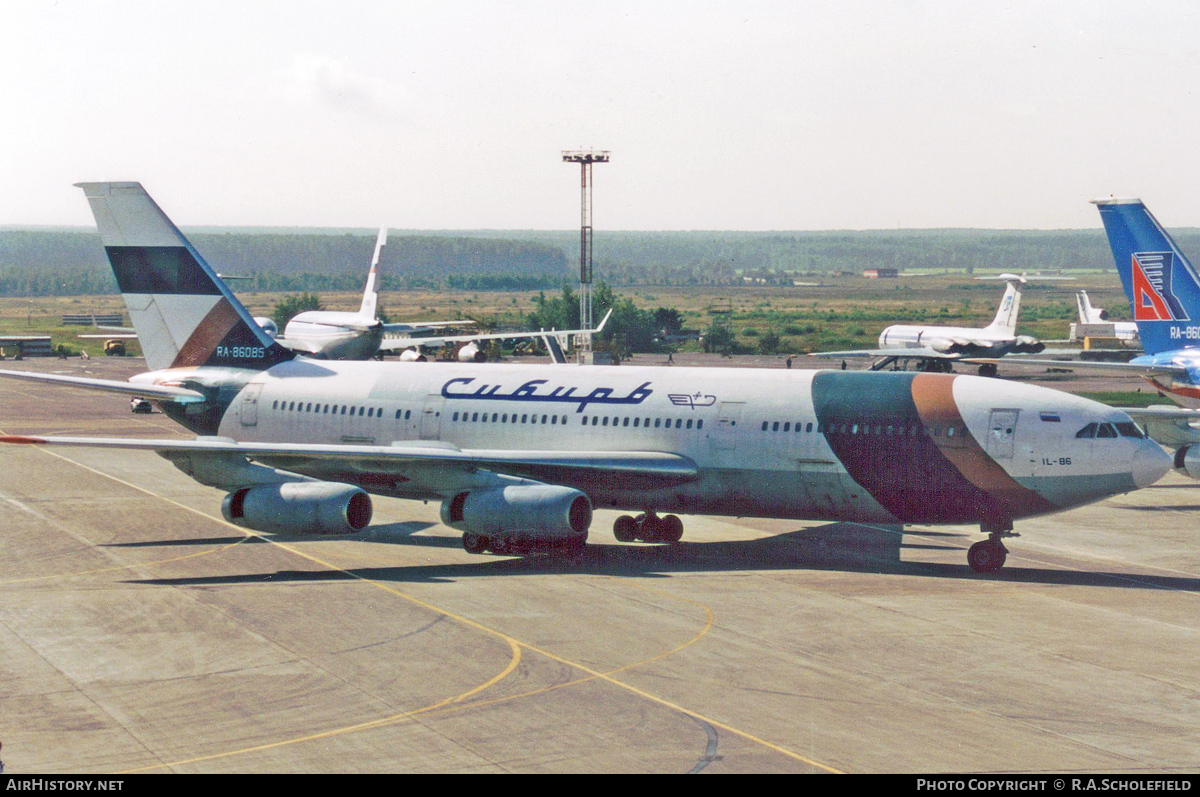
[1092,197,1200,354]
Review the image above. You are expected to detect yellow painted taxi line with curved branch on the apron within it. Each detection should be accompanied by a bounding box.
[23,441,842,774]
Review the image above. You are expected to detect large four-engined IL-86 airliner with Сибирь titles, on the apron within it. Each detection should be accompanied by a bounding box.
[0,182,1170,571]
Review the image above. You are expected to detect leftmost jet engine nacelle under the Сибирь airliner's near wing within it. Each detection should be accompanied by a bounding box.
[221,481,371,534]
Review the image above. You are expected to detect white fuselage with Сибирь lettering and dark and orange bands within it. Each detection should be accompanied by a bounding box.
[192,359,1165,522]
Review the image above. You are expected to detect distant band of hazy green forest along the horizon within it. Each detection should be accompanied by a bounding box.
[0,228,1200,296]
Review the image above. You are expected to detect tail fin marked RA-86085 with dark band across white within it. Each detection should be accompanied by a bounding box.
[76,182,294,371]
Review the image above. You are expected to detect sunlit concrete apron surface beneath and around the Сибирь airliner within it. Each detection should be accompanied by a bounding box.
[0,360,1200,773]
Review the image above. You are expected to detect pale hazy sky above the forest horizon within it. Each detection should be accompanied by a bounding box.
[0,0,1200,230]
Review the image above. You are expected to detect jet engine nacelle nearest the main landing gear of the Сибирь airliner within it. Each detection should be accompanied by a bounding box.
[442,485,592,540]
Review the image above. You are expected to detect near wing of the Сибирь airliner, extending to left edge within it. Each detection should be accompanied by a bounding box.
[0,435,697,491]
